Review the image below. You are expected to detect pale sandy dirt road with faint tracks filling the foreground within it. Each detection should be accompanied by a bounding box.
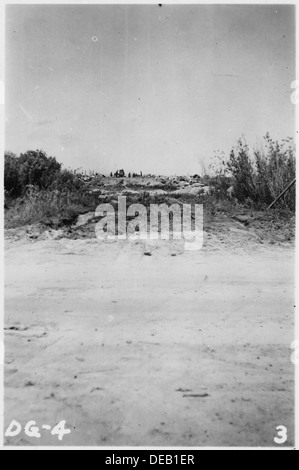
[5,239,294,447]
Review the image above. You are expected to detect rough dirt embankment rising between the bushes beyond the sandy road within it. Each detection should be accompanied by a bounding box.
[6,178,295,249]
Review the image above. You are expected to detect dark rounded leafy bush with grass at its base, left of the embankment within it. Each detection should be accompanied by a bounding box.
[4,150,92,228]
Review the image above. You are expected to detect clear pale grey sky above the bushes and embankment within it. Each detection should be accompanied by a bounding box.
[5,4,295,174]
